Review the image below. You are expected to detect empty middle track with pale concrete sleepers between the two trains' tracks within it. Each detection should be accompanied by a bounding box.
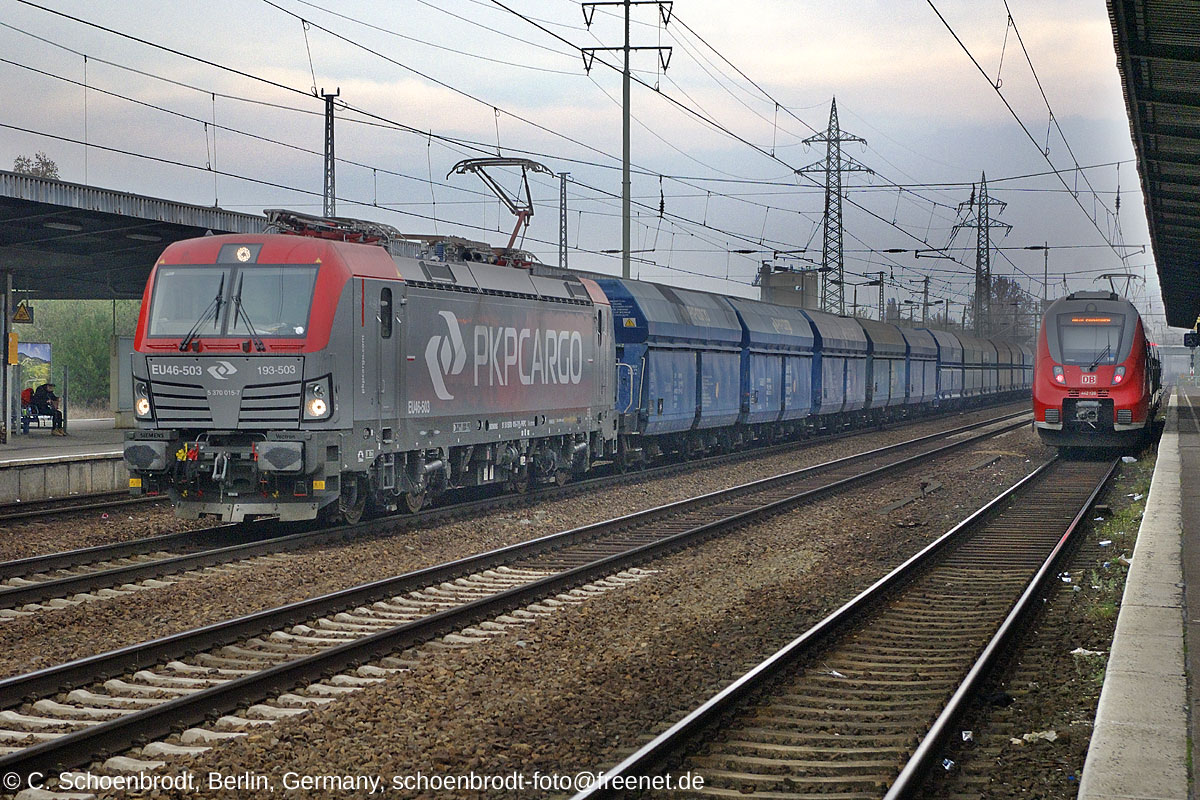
[0,410,1026,775]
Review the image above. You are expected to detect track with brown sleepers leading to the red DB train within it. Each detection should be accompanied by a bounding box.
[574,459,1117,800]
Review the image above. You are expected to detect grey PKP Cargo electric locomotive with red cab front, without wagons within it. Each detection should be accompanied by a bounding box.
[125,211,616,522]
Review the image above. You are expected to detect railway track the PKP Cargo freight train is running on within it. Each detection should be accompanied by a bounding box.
[0,410,1025,624]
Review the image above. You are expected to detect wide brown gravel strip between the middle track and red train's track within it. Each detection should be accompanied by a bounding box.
[98,428,1051,798]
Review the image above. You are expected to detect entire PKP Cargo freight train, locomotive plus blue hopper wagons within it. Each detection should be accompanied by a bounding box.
[125,211,1033,522]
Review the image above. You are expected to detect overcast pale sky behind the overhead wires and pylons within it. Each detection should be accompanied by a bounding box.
[0,0,1176,338]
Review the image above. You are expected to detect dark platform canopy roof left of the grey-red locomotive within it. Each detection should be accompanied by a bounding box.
[0,170,266,300]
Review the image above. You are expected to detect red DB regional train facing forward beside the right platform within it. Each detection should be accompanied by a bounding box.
[1033,291,1162,447]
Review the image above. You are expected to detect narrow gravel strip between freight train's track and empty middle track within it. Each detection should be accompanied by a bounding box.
[0,402,1022,676]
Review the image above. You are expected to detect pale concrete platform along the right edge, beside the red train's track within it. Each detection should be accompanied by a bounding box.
[1079,387,1200,800]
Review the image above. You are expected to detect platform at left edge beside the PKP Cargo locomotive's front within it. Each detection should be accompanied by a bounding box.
[0,419,128,504]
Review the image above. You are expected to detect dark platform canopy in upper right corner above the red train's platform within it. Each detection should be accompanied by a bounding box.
[1109,0,1200,327]
